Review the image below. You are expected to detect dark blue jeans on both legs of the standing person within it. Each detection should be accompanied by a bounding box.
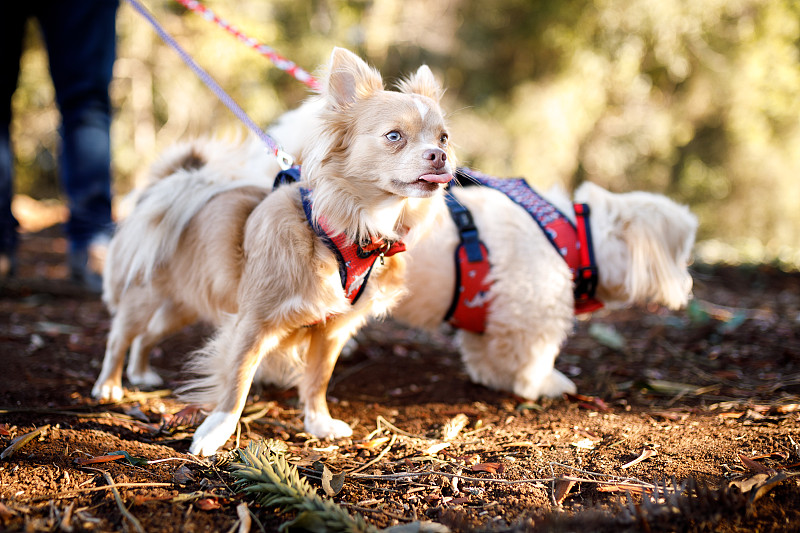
[0,0,118,253]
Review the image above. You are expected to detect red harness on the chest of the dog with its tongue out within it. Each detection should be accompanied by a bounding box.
[300,188,406,304]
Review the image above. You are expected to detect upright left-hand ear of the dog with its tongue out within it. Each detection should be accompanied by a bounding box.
[325,47,383,109]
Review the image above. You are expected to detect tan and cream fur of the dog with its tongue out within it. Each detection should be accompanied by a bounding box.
[93,49,454,455]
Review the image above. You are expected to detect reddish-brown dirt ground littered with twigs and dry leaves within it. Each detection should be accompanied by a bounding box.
[0,228,800,532]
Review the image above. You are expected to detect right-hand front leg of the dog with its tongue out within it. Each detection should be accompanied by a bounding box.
[299,326,353,439]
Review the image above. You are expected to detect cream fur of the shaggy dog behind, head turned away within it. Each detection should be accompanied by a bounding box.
[264,98,697,399]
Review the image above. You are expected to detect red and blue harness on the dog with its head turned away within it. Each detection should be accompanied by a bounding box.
[445,169,603,333]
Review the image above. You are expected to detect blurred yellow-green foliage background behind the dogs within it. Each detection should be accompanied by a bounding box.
[7,0,800,268]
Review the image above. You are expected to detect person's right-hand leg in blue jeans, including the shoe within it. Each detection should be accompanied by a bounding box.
[39,0,117,291]
